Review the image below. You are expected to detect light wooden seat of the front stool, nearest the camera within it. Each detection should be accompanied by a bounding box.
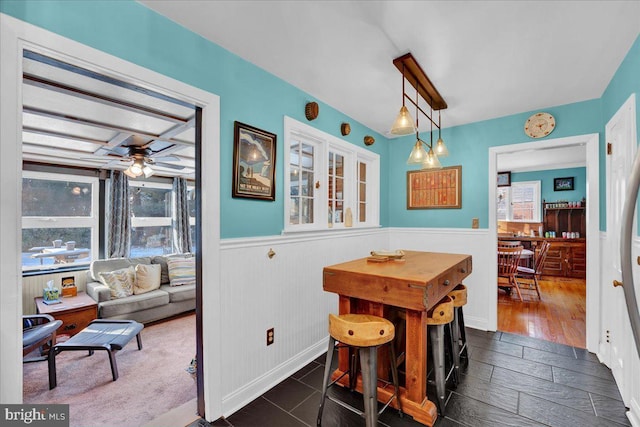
[329,314,395,347]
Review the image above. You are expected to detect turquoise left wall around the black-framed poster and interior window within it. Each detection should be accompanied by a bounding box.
[0,0,389,238]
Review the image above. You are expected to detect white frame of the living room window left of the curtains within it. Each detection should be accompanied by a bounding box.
[21,169,100,273]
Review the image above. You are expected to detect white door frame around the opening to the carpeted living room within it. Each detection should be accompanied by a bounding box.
[0,14,222,419]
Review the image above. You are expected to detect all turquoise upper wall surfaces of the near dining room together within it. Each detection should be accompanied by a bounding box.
[0,0,640,238]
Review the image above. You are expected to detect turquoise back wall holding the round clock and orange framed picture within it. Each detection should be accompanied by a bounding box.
[389,99,602,228]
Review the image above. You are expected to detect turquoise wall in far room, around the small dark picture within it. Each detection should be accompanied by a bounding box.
[511,168,587,206]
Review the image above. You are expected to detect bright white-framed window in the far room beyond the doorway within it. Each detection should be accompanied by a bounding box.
[496,181,542,222]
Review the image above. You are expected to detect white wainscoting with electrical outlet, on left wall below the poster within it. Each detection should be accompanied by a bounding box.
[219,229,388,416]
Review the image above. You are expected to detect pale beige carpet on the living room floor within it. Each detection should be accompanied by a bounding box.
[23,314,196,427]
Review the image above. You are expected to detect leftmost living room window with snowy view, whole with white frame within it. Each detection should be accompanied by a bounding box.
[22,171,99,271]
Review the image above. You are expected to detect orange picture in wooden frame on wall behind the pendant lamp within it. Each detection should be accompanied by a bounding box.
[407,166,462,209]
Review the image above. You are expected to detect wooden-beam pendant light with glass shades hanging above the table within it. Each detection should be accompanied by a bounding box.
[390,53,449,169]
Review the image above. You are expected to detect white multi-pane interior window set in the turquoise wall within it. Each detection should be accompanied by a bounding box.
[284,117,380,231]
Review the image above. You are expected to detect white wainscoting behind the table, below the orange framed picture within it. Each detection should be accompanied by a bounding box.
[389,228,497,331]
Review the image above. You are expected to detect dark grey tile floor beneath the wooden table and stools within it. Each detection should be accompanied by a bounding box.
[191,329,630,427]
